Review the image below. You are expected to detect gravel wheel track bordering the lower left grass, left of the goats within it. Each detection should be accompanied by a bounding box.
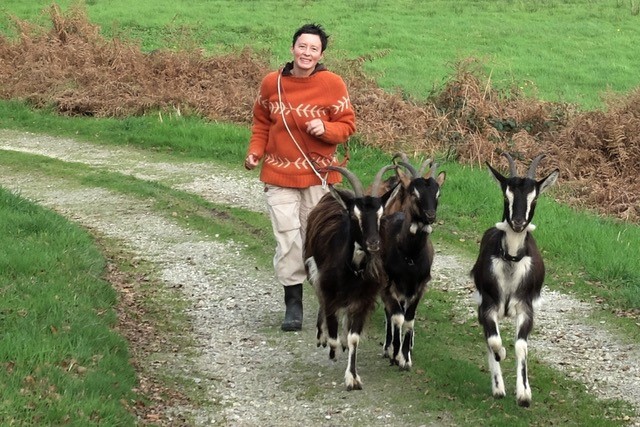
[0,171,416,426]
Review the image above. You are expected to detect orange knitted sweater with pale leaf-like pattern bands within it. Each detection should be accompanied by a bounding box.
[247,64,356,188]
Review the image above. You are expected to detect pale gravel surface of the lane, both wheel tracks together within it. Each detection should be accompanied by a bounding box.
[0,130,640,426]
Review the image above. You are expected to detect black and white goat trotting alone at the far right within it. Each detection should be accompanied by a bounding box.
[471,153,559,407]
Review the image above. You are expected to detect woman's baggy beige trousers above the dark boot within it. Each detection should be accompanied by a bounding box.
[265,184,329,286]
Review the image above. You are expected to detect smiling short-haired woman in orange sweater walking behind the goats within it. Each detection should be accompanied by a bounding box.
[244,24,356,331]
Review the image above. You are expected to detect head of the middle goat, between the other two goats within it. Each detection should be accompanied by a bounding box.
[390,156,446,225]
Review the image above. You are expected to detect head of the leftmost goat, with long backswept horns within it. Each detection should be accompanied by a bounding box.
[327,165,396,253]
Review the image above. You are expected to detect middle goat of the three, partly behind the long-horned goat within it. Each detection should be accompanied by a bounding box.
[381,155,446,370]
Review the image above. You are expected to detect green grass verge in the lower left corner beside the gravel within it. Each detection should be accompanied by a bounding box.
[0,189,139,425]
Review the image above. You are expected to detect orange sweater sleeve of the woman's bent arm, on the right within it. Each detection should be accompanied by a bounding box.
[320,74,356,144]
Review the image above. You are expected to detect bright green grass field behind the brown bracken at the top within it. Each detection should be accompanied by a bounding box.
[0,0,640,109]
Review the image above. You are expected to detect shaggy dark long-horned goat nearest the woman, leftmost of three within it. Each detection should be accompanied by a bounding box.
[304,165,395,390]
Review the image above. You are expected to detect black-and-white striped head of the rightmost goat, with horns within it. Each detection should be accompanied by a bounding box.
[487,152,560,233]
